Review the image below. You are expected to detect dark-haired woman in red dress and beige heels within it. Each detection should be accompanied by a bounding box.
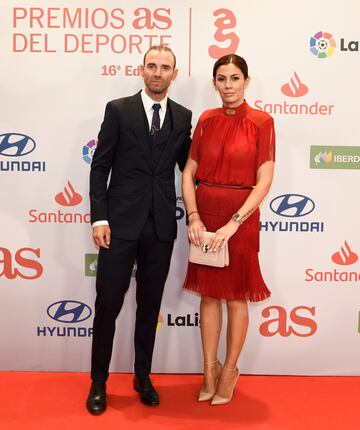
[183,54,275,405]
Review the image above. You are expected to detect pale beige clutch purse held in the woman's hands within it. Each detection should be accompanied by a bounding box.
[189,231,229,267]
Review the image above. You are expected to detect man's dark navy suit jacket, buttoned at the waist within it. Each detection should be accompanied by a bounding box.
[90,92,191,241]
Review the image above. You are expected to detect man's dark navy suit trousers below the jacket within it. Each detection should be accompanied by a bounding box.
[91,215,174,381]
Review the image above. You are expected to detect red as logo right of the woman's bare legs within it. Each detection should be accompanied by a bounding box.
[259,306,317,337]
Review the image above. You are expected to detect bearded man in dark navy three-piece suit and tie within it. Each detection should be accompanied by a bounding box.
[86,45,191,414]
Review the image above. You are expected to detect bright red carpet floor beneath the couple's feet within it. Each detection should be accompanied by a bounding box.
[0,372,360,430]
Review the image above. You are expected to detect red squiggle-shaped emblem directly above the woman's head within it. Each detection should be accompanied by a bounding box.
[209,9,240,59]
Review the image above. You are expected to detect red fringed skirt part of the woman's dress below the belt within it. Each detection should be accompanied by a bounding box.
[184,183,271,302]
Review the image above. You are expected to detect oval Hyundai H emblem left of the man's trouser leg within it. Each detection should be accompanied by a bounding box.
[46,300,92,323]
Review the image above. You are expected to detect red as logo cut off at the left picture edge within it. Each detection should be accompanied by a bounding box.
[0,247,43,280]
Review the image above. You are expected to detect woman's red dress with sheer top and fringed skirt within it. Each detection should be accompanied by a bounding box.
[184,102,275,302]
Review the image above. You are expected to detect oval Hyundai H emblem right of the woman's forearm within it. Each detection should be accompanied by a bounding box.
[270,194,315,218]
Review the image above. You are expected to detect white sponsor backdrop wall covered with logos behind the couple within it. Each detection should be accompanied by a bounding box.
[0,0,360,375]
